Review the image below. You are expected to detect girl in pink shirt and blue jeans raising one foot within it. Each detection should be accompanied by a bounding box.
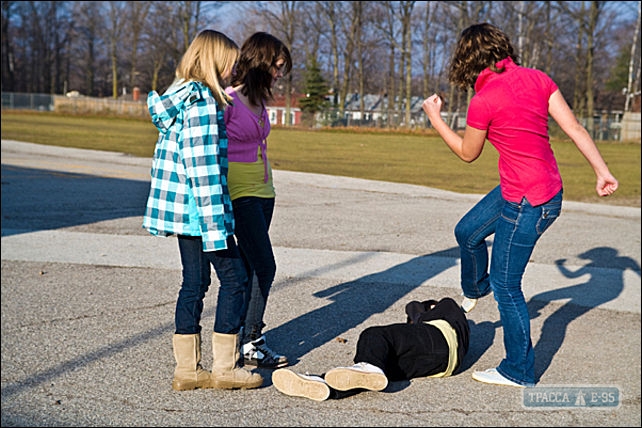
[423,23,618,387]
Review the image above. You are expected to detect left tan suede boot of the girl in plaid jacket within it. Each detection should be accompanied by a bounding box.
[172,334,211,391]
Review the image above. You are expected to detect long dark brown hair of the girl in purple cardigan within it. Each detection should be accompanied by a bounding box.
[232,31,292,106]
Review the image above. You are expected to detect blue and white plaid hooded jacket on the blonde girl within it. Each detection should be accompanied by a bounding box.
[143,82,234,251]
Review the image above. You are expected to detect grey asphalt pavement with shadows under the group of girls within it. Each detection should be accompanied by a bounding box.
[1,140,641,427]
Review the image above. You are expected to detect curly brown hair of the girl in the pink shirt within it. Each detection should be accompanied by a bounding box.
[448,23,519,90]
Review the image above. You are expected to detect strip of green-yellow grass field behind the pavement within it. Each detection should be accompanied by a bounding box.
[2,110,640,207]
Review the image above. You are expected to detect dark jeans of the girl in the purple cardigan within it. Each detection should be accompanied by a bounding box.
[232,196,276,344]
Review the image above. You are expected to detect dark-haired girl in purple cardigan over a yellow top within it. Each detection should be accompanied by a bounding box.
[225,32,292,368]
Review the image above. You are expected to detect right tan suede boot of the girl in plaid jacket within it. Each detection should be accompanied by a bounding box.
[211,333,263,389]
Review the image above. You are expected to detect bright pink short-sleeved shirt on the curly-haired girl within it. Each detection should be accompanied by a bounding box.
[466,58,562,206]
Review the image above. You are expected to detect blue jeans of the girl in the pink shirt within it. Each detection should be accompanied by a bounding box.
[455,186,562,386]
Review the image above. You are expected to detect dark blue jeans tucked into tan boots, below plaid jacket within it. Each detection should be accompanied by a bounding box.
[174,235,248,334]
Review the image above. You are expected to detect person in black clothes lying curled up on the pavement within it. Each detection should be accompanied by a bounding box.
[272,297,470,401]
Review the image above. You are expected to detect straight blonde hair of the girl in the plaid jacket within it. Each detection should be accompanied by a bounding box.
[176,30,240,107]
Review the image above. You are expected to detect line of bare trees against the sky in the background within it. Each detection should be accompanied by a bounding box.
[2,1,640,128]
